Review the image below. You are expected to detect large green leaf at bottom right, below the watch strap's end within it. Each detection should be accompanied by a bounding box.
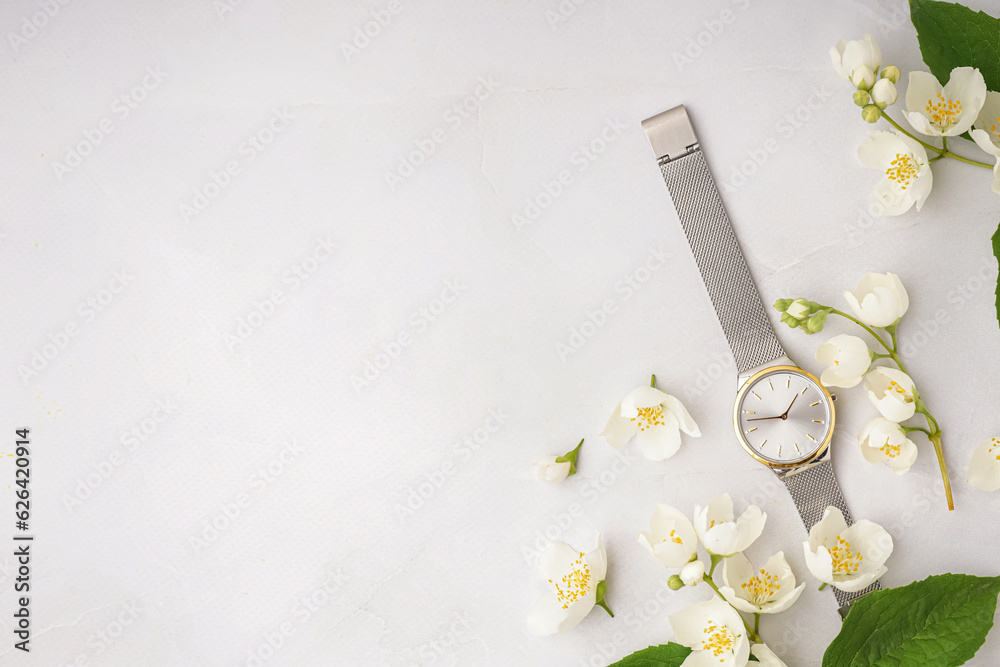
[823,574,1000,667]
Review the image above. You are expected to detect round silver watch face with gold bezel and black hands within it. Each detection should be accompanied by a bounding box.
[733,366,834,468]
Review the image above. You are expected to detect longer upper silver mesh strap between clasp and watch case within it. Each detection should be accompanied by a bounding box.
[659,147,785,371]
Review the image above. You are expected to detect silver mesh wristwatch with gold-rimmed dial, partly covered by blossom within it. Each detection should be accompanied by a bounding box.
[642,106,879,615]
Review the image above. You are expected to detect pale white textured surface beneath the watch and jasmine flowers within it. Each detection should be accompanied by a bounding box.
[0,0,1000,667]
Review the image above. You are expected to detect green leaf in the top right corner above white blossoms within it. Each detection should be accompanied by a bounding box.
[910,0,1000,91]
